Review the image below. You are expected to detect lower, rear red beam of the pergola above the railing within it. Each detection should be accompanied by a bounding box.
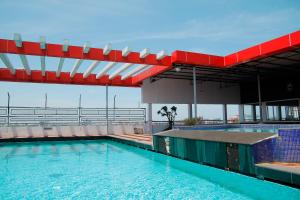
[0,68,140,87]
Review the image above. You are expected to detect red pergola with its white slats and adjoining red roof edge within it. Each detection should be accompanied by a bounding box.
[0,31,300,87]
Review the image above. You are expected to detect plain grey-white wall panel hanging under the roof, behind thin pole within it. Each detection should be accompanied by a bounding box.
[142,79,240,104]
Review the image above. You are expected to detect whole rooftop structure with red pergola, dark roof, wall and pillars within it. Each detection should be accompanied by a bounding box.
[0,31,300,123]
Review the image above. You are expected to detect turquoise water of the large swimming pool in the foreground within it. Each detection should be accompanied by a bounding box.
[0,140,300,200]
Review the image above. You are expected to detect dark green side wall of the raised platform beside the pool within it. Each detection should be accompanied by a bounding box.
[153,135,255,175]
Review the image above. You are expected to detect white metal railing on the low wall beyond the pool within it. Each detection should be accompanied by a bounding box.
[0,106,146,125]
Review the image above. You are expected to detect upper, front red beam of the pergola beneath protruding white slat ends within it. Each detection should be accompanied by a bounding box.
[0,39,171,66]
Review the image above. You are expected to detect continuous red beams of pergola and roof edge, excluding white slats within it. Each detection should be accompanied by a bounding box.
[0,31,300,87]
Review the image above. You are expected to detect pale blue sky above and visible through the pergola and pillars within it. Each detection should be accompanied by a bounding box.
[0,0,300,120]
